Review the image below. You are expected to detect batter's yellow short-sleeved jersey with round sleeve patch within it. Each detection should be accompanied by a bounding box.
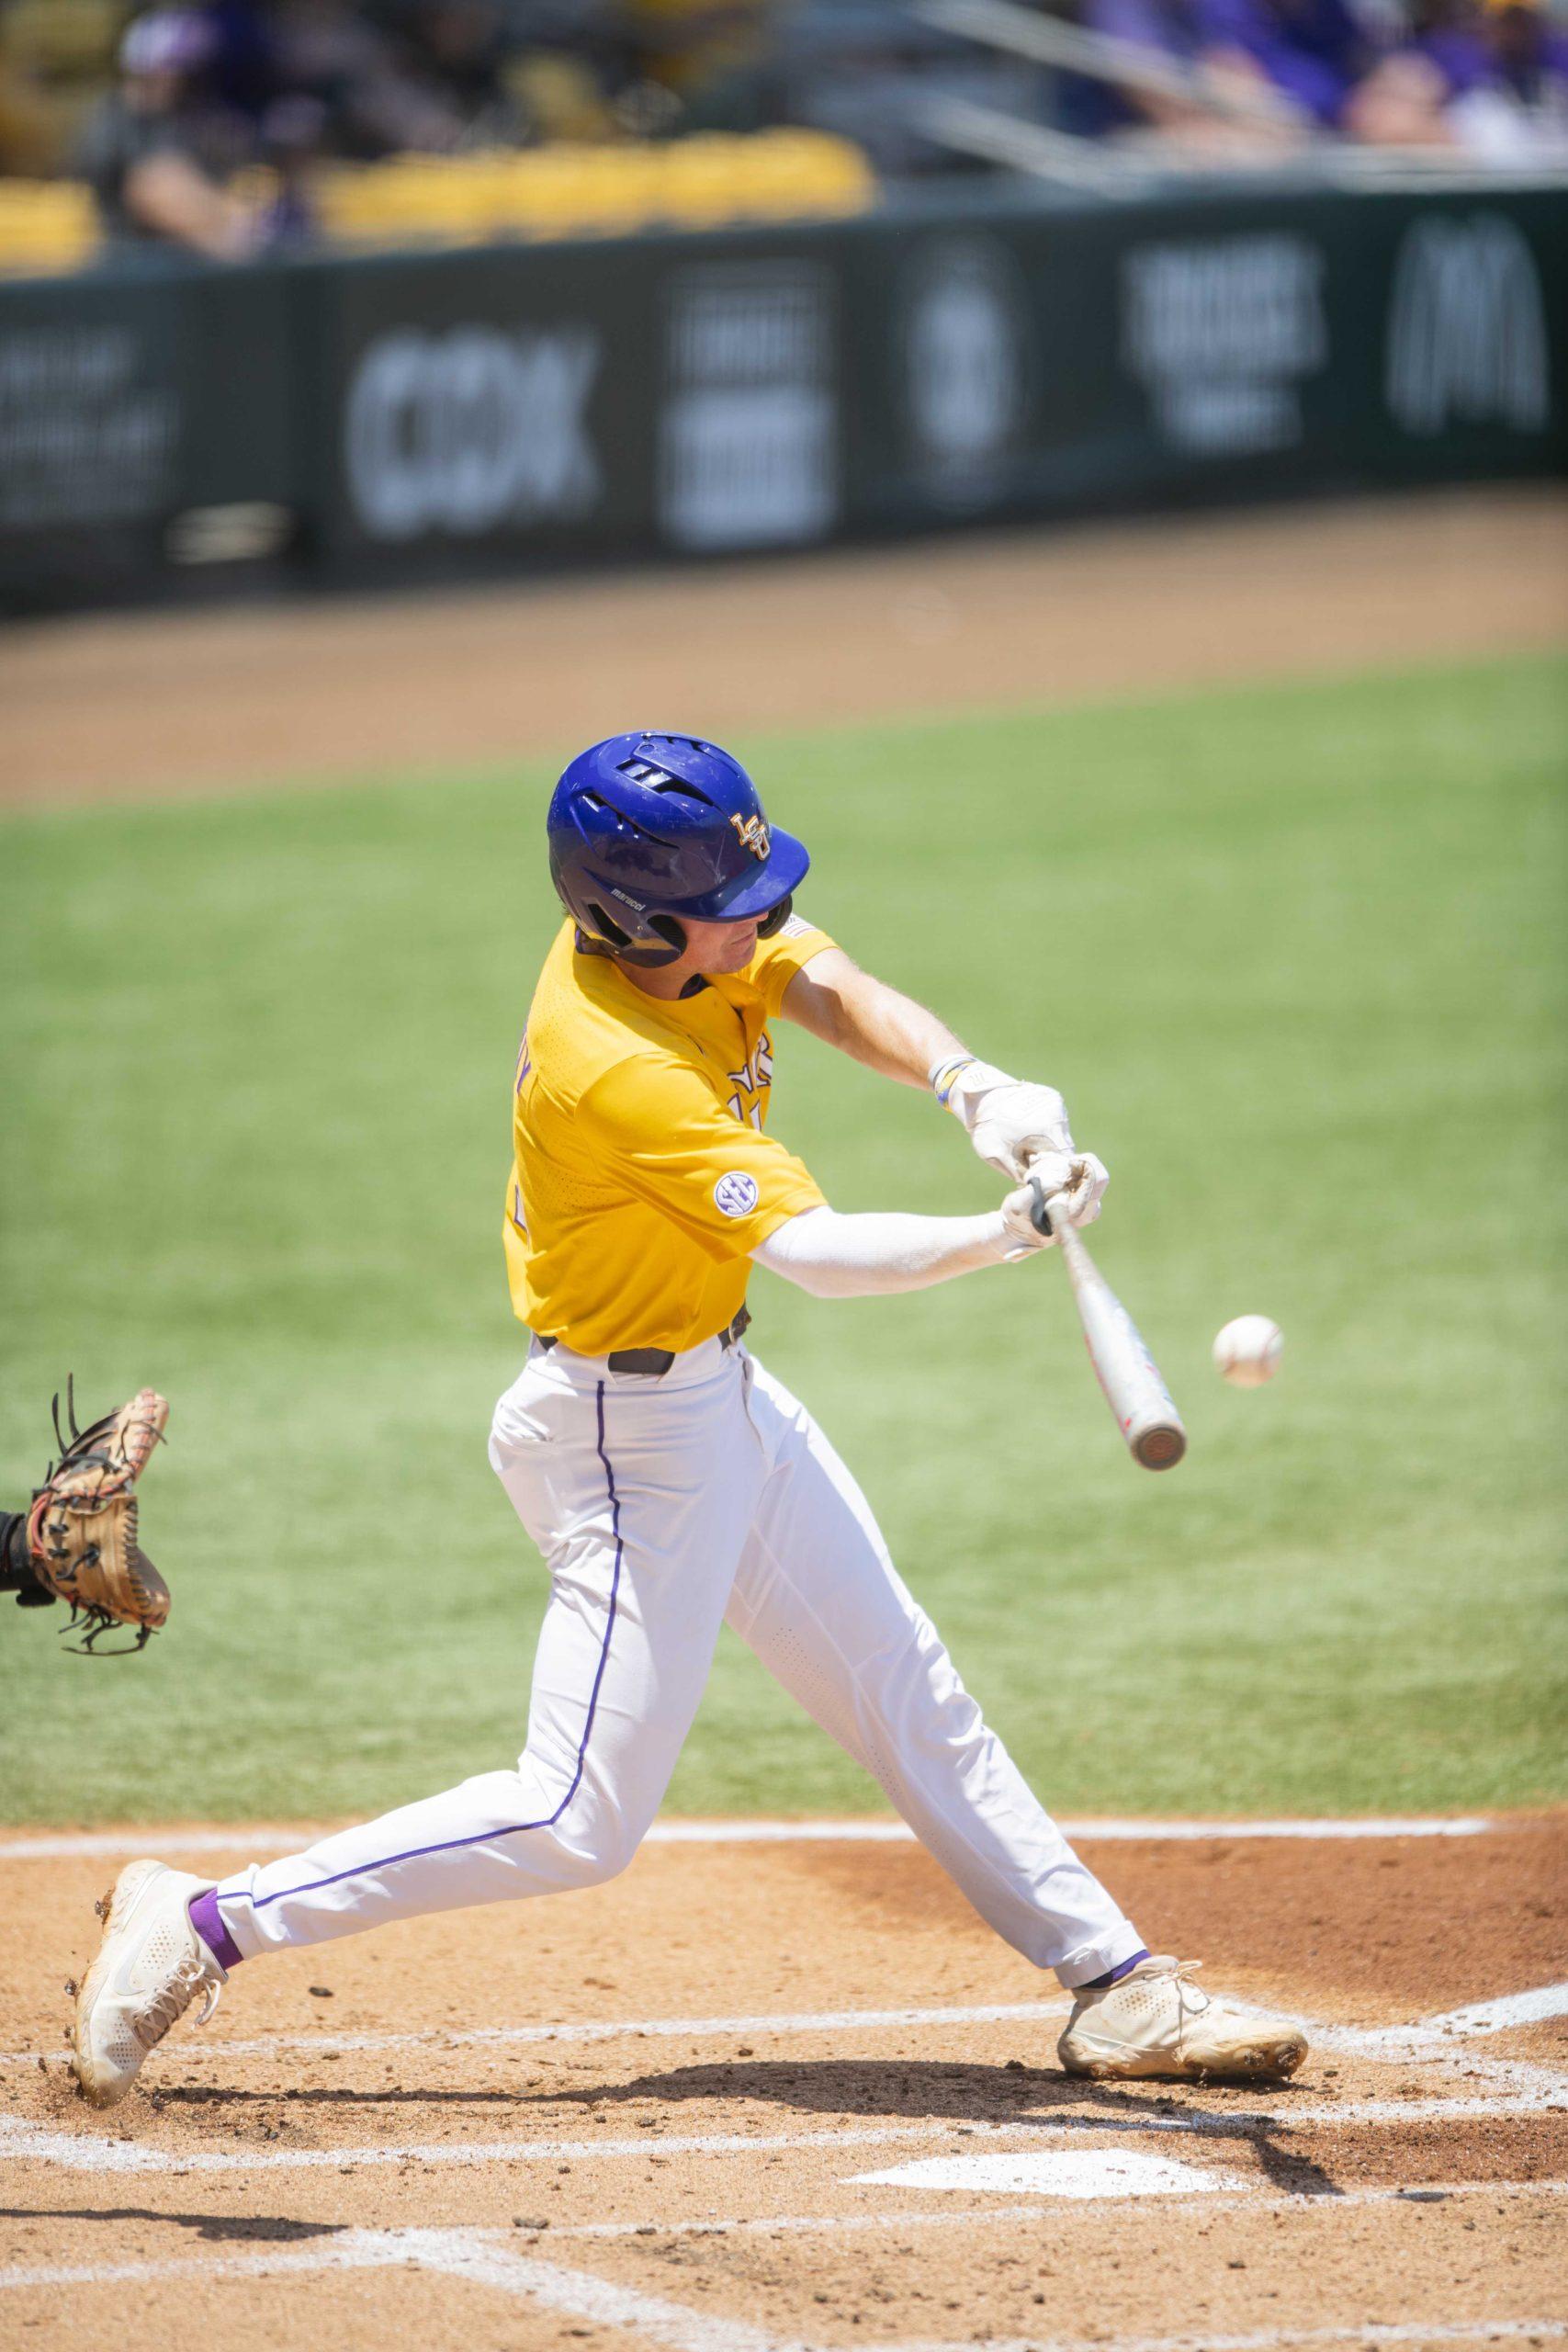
[503,915,832,1355]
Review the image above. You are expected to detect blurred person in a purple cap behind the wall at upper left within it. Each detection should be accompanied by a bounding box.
[77,9,259,261]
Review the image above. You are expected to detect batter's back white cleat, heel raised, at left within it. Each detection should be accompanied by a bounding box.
[71,1863,228,2108]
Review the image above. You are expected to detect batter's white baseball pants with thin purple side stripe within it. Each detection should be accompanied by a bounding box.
[216,1340,1143,1985]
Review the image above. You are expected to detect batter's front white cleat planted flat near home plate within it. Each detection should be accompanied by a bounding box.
[1055,1959,1307,2082]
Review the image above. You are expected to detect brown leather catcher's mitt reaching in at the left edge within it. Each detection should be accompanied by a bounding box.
[9,1383,169,1656]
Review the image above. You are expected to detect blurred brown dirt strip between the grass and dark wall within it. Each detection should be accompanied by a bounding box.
[0,487,1568,805]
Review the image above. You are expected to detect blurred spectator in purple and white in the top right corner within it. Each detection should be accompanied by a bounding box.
[1349,0,1568,167]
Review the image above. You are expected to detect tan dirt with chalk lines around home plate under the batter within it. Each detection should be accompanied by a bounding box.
[0,1814,1568,2352]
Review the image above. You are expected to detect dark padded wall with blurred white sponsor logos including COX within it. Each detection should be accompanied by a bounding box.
[0,186,1568,612]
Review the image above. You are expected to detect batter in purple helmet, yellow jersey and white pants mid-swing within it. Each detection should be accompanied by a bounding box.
[73,734,1307,2108]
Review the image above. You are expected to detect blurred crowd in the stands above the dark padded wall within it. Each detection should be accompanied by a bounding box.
[0,0,1568,266]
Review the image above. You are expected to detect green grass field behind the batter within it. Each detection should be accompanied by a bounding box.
[0,661,1568,1823]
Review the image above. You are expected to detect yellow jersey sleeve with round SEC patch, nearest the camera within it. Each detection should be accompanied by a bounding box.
[576,1054,823,1263]
